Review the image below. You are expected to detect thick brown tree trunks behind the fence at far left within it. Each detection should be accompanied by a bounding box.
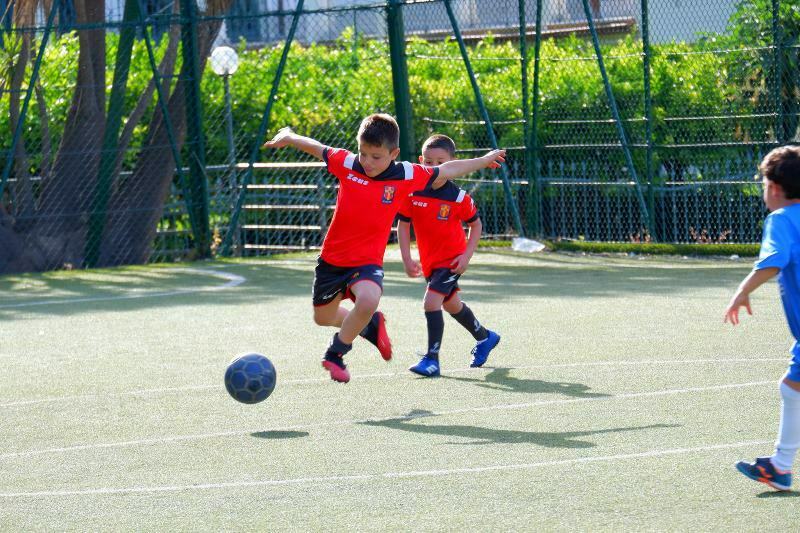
[0,0,233,272]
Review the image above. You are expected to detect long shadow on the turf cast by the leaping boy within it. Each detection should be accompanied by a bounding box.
[360,411,678,448]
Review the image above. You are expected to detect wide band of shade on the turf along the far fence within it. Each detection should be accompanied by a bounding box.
[0,251,742,319]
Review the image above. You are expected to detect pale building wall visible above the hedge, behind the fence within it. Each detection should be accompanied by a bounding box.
[97,0,737,43]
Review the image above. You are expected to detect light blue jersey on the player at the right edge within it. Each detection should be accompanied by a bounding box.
[755,204,800,356]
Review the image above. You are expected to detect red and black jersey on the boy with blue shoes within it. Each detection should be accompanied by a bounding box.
[400,182,478,278]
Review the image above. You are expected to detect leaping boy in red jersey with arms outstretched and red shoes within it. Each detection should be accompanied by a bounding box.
[264,114,505,383]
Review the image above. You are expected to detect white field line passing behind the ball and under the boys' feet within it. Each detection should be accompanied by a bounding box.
[0,357,788,409]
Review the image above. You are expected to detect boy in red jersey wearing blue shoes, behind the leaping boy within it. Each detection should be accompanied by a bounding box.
[397,135,500,377]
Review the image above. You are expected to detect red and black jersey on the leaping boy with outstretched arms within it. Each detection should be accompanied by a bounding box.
[320,148,439,267]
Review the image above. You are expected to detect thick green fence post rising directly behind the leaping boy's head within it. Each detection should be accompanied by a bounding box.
[386,0,416,161]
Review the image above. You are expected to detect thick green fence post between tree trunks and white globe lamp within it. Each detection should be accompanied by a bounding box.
[181,0,211,257]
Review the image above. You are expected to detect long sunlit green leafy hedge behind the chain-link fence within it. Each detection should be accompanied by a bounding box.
[0,7,784,180]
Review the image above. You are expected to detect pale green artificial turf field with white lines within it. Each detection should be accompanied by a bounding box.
[0,251,800,531]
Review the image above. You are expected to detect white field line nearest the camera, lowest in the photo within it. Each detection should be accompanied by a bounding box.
[0,441,772,499]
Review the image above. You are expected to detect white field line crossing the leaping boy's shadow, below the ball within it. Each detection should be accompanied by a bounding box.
[0,380,776,459]
